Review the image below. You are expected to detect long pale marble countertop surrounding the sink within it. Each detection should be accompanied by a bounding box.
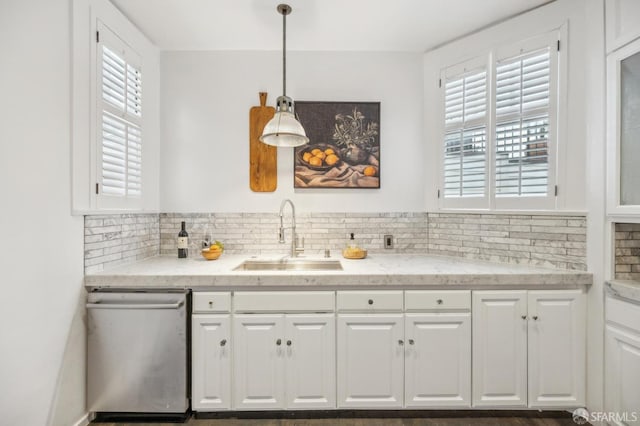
[85,254,593,290]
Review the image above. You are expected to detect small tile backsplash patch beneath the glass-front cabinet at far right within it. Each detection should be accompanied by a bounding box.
[615,223,640,280]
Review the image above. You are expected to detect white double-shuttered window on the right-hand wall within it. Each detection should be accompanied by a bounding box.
[440,33,559,209]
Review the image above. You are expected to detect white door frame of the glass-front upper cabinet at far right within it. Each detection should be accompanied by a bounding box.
[606,38,640,217]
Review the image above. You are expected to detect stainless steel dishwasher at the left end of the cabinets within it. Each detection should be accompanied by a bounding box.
[87,291,189,420]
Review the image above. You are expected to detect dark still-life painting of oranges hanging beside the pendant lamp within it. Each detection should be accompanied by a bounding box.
[293,101,380,188]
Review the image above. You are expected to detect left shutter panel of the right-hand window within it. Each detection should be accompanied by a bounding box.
[443,61,488,198]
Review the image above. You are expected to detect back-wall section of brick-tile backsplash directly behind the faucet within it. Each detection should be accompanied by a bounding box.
[160,211,427,256]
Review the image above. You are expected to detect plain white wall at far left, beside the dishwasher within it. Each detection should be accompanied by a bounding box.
[0,0,84,426]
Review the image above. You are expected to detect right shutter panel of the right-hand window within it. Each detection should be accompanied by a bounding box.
[495,46,556,197]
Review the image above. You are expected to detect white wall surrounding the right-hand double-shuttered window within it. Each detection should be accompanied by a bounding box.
[424,0,588,211]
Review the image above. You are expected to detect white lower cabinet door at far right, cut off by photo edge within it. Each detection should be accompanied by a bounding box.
[604,323,640,426]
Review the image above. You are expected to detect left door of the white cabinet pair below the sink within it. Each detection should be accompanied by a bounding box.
[233,314,286,410]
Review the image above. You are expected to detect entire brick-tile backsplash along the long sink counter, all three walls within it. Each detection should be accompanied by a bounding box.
[85,211,592,273]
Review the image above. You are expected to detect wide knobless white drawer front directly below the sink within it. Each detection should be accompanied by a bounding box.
[233,291,335,313]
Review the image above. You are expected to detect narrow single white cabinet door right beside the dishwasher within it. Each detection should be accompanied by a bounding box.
[191,314,231,411]
